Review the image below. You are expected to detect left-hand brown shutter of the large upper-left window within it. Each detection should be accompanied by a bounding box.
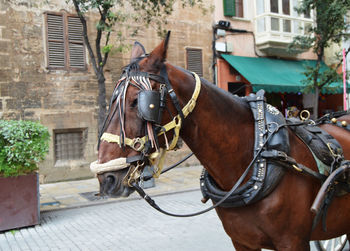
[47,14,65,68]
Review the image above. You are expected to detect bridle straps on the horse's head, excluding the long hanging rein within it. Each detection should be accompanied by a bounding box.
[90,61,201,186]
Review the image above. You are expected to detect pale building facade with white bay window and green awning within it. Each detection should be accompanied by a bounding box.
[214,0,342,115]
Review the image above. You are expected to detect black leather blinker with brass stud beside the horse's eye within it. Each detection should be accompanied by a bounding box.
[138,90,160,124]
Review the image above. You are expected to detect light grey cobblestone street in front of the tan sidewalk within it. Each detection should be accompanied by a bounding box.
[0,191,233,251]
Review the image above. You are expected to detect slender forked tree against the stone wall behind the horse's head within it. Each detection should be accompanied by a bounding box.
[67,0,205,132]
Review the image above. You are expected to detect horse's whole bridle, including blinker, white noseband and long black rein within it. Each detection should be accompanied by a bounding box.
[90,56,292,217]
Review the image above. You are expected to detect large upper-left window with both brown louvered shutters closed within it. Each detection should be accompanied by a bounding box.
[46,13,86,70]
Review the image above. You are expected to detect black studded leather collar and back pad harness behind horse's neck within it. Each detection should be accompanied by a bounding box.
[200,90,344,207]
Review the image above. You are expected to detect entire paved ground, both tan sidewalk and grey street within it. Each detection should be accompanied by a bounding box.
[0,166,349,251]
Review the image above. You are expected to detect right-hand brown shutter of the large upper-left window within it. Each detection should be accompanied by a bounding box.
[68,16,85,69]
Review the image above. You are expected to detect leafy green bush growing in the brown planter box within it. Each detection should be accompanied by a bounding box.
[0,120,50,177]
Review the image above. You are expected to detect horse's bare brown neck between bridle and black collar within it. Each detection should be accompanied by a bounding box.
[172,70,254,190]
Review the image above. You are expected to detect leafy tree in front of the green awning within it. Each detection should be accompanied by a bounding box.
[290,0,350,118]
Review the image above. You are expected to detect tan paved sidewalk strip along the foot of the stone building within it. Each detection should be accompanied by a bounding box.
[40,166,202,212]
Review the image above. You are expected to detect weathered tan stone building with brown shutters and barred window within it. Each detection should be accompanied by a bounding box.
[0,0,213,183]
